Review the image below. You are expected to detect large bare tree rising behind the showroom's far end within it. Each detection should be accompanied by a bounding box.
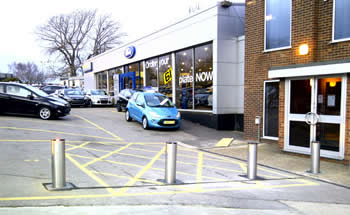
[35,10,124,76]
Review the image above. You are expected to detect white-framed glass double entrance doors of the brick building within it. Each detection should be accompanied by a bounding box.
[285,77,346,159]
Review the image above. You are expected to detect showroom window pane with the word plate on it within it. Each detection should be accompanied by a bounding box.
[175,49,193,109]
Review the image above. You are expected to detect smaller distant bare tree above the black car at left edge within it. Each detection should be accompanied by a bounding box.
[8,62,46,84]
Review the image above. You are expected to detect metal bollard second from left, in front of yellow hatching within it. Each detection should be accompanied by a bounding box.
[165,142,177,184]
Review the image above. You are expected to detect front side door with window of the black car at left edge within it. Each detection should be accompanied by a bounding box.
[6,85,38,114]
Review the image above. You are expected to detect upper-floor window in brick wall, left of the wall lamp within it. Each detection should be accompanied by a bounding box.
[265,0,292,50]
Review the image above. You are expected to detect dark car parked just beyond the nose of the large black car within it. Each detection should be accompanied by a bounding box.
[59,88,92,107]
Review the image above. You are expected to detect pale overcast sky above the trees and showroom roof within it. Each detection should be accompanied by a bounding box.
[0,0,244,73]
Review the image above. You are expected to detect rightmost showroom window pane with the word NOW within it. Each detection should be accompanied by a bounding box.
[194,44,213,110]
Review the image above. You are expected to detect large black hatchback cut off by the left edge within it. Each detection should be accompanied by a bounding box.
[0,82,71,120]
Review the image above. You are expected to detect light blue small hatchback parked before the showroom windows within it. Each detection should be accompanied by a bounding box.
[125,92,181,129]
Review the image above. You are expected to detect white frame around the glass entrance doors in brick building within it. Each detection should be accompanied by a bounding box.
[283,74,347,160]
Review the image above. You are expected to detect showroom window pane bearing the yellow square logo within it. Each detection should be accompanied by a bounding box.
[158,54,173,100]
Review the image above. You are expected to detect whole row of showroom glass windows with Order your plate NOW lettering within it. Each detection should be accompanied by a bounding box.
[96,43,213,111]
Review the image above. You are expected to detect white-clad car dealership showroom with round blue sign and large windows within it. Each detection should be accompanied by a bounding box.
[83,1,245,131]
